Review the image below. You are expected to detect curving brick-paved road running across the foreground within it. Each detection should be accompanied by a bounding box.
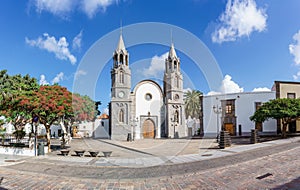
[0,137,300,189]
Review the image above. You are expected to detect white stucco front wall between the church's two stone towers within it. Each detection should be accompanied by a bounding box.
[133,80,163,139]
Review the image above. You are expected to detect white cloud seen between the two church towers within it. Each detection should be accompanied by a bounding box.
[143,52,169,78]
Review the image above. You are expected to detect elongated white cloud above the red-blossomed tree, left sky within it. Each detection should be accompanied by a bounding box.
[25,33,77,65]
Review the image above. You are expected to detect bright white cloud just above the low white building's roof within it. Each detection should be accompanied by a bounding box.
[207,75,244,95]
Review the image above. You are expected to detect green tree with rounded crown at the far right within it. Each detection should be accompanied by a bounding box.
[250,98,300,137]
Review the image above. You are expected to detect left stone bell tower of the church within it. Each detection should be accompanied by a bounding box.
[110,34,131,140]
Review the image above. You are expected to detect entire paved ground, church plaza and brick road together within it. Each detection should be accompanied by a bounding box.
[0,138,300,189]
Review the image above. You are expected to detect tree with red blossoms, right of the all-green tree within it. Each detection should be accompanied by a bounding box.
[19,85,96,151]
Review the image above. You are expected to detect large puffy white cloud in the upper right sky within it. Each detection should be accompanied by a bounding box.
[212,0,268,43]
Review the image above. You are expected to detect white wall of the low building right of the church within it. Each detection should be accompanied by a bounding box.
[203,91,277,136]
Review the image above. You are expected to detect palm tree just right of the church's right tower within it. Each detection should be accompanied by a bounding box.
[184,90,202,118]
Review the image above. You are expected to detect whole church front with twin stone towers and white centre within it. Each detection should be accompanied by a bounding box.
[109,35,187,140]
